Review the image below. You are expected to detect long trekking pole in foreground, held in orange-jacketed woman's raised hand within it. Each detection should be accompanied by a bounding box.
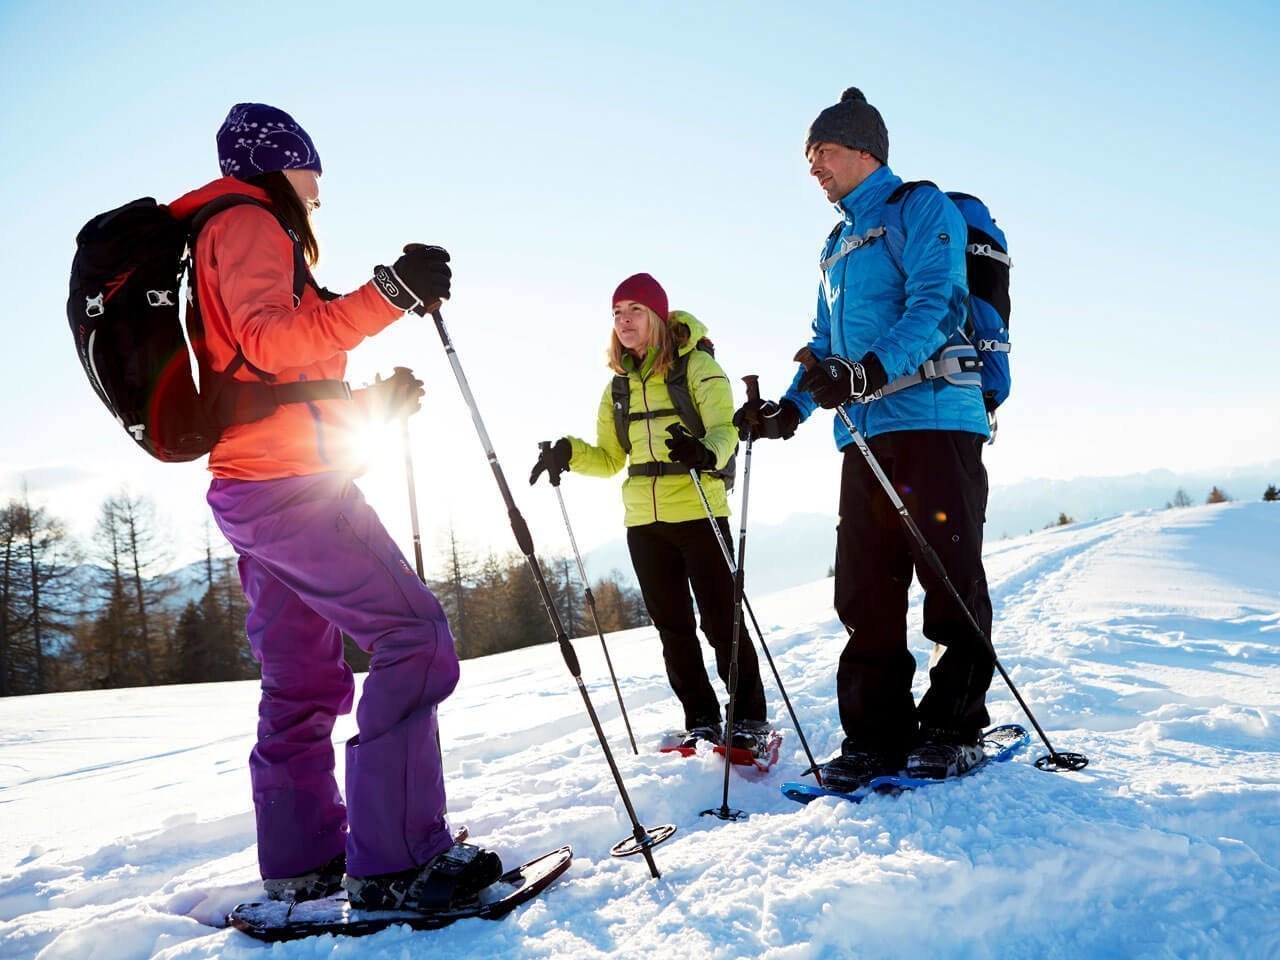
[431,306,676,879]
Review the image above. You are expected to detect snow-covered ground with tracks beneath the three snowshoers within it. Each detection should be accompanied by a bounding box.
[0,503,1280,960]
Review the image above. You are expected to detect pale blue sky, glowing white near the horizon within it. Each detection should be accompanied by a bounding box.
[0,3,1280,570]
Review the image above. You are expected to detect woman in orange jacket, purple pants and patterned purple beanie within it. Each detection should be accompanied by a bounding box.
[181,104,502,910]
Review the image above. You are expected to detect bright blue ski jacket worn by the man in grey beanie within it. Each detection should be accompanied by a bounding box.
[783,166,988,449]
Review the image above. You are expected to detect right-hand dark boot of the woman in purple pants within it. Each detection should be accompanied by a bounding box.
[342,842,502,913]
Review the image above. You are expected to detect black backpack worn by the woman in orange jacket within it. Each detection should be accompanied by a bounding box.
[67,195,351,462]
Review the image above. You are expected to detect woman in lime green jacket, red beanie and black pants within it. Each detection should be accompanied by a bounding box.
[529,274,769,753]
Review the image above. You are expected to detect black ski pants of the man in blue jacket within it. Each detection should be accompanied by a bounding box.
[836,430,995,753]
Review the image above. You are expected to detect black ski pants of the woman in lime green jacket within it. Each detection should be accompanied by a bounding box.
[627,517,767,730]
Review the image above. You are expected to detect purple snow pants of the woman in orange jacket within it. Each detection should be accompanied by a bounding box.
[209,474,458,878]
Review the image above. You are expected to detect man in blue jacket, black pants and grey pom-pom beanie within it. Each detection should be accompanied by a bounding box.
[735,88,995,790]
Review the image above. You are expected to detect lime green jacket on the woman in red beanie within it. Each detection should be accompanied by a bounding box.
[568,310,737,526]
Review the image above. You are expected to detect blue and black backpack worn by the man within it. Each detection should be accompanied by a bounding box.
[884,180,1011,439]
